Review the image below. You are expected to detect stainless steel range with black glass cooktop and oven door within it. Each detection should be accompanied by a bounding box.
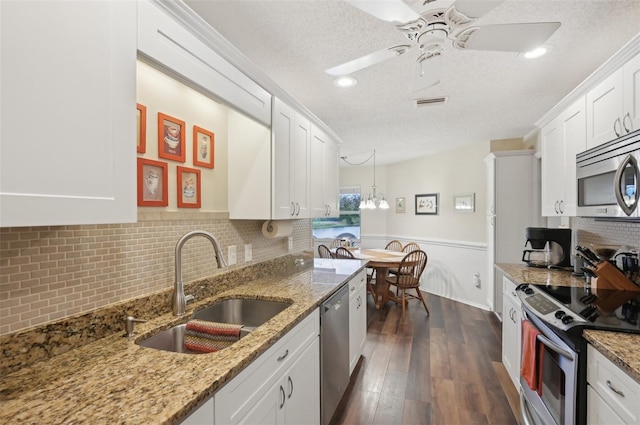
[517,282,640,425]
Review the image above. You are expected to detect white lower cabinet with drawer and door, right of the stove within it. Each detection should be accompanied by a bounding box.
[587,345,640,425]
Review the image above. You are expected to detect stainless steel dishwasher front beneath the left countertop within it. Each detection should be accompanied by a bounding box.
[320,285,349,425]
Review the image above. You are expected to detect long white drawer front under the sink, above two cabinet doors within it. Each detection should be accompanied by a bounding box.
[214,310,320,424]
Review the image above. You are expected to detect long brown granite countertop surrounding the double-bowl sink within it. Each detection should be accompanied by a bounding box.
[0,259,366,424]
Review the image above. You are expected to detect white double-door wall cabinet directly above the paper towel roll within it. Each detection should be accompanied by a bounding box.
[272,98,311,219]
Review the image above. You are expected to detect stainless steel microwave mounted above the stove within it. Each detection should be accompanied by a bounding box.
[576,130,640,220]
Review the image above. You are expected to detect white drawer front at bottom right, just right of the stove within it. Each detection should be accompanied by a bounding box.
[587,345,640,424]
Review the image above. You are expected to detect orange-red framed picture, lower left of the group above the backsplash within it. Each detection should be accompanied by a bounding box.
[138,158,169,207]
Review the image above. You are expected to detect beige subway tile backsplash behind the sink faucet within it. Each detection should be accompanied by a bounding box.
[0,212,313,335]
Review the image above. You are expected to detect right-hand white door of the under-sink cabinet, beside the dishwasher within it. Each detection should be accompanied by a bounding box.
[282,338,320,425]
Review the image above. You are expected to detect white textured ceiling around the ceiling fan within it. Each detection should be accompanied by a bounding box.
[186,0,640,164]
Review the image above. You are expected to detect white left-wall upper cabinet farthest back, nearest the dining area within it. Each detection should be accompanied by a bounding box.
[310,125,340,217]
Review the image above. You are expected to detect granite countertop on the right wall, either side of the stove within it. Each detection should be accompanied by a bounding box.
[496,263,640,382]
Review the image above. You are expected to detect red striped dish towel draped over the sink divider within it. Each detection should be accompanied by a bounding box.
[184,320,242,353]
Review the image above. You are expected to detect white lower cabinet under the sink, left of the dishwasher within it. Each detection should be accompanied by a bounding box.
[214,310,320,425]
